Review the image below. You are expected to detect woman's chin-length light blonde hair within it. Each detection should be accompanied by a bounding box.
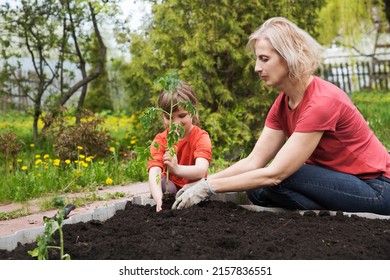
[247,17,322,80]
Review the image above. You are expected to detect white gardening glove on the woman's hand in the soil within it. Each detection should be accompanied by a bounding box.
[172,178,216,209]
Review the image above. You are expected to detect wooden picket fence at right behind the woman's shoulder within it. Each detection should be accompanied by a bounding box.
[322,60,390,93]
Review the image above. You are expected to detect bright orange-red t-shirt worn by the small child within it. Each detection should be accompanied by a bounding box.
[148,125,212,187]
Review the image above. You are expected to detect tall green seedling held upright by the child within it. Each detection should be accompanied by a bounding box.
[141,71,196,192]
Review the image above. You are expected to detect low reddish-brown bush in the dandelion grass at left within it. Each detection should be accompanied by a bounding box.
[44,110,114,160]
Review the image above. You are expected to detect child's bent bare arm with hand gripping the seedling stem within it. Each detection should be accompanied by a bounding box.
[164,152,209,180]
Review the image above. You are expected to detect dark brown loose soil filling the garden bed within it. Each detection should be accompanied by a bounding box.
[0,201,390,260]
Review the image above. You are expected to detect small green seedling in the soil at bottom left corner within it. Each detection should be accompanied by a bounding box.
[28,199,76,260]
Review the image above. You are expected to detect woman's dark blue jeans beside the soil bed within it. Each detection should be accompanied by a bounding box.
[247,164,390,215]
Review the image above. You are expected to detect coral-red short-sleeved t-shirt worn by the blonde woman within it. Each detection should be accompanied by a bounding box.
[265,77,390,179]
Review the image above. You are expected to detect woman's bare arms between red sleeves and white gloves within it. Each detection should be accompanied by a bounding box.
[209,131,324,192]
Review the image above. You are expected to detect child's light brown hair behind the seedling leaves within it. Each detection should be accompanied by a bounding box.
[157,81,200,125]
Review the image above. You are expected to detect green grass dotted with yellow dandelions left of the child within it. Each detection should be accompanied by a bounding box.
[0,112,147,203]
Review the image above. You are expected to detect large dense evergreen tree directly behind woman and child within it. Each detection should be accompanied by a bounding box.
[124,0,324,158]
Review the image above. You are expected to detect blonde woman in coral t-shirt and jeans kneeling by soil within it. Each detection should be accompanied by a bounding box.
[173,17,390,215]
